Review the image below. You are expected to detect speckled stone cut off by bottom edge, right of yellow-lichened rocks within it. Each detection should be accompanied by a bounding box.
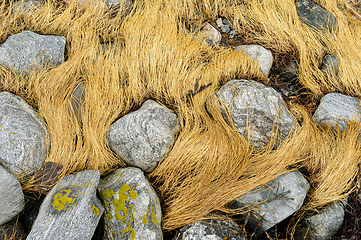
[173,219,245,240]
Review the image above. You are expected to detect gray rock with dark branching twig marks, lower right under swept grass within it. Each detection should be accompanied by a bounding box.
[231,171,310,235]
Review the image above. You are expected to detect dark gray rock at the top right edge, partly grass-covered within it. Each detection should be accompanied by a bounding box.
[296,0,337,33]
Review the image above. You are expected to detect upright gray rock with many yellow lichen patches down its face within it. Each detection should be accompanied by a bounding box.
[98,167,163,240]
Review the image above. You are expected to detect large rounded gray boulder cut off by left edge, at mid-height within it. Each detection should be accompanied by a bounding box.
[0,92,50,175]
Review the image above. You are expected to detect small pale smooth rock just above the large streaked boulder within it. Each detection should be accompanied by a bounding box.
[236,45,273,76]
